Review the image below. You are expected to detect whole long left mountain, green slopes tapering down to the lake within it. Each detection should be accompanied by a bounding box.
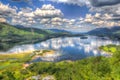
[0,23,69,51]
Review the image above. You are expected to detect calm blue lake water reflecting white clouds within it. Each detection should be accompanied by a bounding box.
[2,36,120,61]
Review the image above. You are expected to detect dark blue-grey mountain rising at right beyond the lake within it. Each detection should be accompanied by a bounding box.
[87,26,120,40]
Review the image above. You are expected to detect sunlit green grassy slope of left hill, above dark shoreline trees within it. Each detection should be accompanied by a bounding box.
[0,23,44,41]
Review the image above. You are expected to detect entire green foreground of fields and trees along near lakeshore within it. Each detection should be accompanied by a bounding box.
[0,45,120,80]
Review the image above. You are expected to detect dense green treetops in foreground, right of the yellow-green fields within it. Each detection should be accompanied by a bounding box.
[28,45,120,80]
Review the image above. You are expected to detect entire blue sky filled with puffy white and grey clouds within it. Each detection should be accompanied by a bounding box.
[0,0,120,30]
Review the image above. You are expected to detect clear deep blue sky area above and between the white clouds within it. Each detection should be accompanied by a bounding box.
[0,0,89,18]
